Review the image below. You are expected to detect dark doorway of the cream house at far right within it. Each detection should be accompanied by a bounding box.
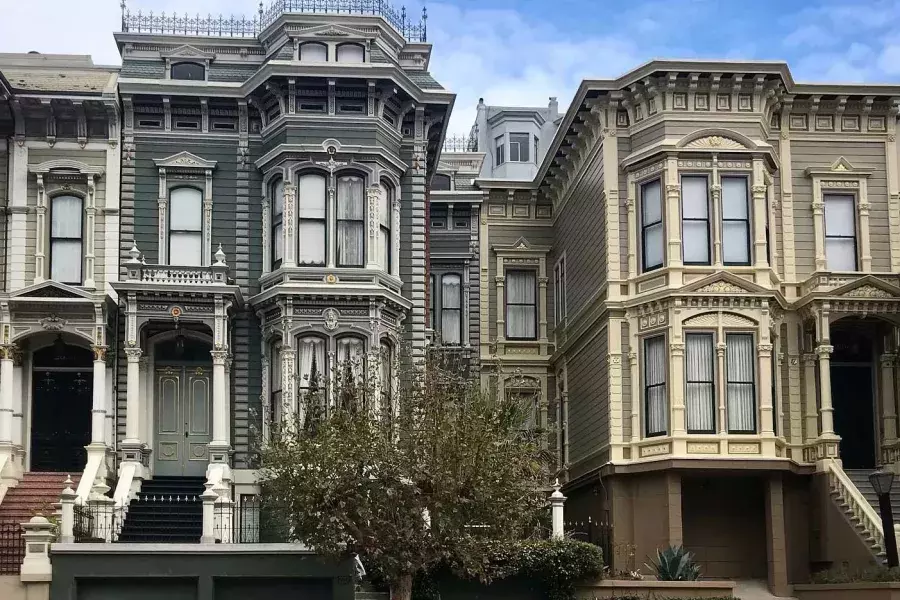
[831,318,884,469]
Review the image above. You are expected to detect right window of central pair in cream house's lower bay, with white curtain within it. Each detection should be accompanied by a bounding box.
[725,333,756,433]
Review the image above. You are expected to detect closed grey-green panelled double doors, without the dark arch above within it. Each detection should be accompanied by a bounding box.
[154,366,212,476]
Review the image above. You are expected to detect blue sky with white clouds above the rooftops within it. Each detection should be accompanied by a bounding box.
[0,0,900,134]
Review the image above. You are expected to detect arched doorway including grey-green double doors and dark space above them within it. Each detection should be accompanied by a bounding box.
[153,331,212,477]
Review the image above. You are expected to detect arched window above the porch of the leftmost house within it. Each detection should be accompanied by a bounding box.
[50,196,84,285]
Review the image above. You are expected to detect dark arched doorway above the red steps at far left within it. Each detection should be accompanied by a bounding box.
[30,335,94,473]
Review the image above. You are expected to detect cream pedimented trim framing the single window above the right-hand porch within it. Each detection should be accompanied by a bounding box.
[806,157,872,273]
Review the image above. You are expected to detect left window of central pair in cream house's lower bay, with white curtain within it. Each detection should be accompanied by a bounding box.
[684,333,716,433]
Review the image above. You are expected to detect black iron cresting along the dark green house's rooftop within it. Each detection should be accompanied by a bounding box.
[122,0,428,42]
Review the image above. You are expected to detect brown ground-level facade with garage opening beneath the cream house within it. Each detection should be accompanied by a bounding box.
[566,461,874,596]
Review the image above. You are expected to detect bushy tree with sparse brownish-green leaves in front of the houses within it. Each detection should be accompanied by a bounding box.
[261,346,547,600]
